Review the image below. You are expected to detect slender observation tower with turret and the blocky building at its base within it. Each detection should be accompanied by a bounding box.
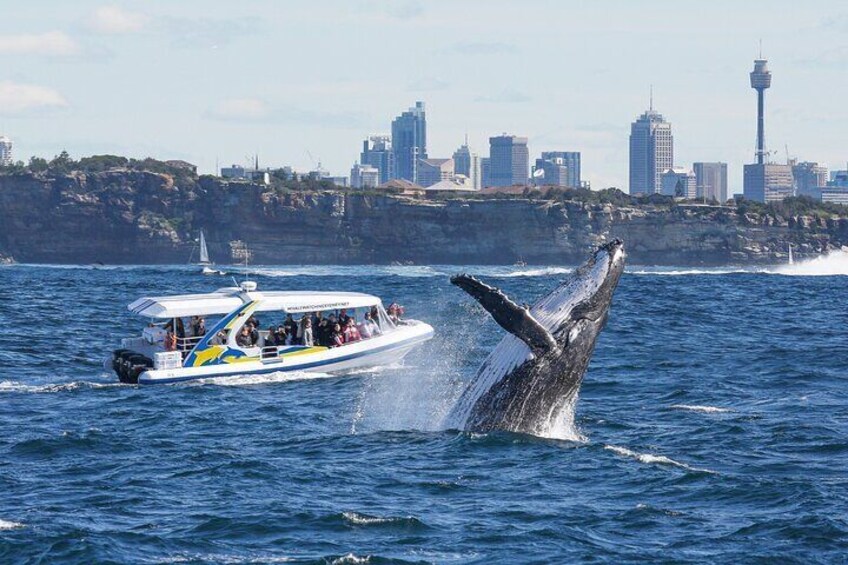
[742,58,795,202]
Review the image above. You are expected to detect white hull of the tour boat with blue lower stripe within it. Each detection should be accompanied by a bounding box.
[138,322,433,385]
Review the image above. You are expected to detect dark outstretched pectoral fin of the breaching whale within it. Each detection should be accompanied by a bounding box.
[451,275,557,354]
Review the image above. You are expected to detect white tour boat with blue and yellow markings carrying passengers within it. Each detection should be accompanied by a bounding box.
[107,281,434,384]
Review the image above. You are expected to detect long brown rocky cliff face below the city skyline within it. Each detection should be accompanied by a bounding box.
[0,171,848,265]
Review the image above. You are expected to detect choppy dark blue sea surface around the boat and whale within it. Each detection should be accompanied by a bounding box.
[0,254,848,564]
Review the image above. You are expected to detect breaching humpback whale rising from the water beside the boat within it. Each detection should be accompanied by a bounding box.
[447,239,624,436]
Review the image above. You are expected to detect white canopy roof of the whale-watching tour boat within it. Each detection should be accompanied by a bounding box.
[127,287,380,319]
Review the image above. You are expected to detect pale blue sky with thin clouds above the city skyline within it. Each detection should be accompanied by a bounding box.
[0,0,848,192]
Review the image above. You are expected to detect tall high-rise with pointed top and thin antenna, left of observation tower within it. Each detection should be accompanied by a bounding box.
[630,100,674,194]
